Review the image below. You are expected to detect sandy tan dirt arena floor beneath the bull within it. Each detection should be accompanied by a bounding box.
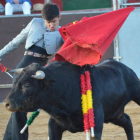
[0,102,140,140]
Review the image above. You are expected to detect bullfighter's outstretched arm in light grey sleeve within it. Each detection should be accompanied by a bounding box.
[0,20,33,59]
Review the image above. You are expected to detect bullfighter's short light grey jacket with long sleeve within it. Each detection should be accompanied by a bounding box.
[0,18,63,59]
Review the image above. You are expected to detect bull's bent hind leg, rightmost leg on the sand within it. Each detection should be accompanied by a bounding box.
[111,113,134,140]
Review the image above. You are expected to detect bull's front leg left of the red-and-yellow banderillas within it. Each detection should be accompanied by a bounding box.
[49,118,64,140]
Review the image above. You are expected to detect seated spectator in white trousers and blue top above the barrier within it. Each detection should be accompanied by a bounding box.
[5,0,32,15]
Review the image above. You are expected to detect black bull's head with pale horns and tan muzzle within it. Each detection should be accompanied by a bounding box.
[3,63,53,112]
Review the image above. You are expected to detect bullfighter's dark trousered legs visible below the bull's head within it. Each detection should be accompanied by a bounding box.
[3,112,28,140]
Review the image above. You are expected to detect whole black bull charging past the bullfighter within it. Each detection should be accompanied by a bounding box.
[4,60,140,140]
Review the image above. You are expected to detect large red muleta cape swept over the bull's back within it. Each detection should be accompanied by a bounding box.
[54,7,134,66]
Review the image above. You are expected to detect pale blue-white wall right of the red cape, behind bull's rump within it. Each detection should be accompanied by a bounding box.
[118,8,140,78]
